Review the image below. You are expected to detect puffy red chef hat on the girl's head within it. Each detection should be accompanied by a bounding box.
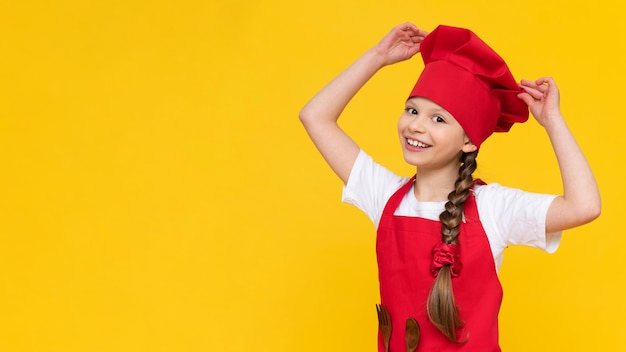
[409,25,528,147]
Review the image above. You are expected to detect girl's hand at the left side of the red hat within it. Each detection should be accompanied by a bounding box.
[373,22,428,65]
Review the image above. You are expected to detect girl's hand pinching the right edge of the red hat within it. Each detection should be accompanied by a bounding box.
[517,77,561,127]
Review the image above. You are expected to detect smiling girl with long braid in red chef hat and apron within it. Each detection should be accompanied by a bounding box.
[300,23,601,351]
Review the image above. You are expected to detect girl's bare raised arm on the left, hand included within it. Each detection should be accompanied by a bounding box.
[300,23,427,183]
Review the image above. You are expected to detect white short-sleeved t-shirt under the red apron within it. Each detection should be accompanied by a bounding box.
[342,150,561,270]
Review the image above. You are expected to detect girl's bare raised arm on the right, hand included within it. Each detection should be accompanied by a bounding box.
[519,77,602,232]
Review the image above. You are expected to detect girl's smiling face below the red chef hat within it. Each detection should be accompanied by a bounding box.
[398,97,476,171]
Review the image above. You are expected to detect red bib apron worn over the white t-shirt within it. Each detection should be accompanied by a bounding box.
[376,177,502,352]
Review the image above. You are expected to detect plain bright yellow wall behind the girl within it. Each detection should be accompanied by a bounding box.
[0,0,626,352]
